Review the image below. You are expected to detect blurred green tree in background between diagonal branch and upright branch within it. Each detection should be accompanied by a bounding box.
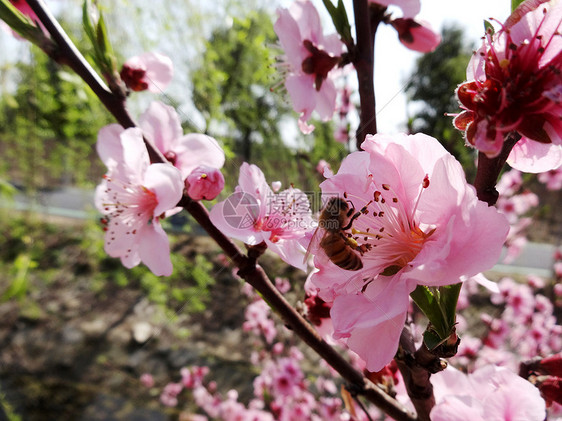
[191,10,345,194]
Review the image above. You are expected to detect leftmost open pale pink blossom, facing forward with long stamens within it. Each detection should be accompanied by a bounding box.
[95,124,183,276]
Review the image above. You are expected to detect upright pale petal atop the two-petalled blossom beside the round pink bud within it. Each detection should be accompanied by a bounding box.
[139,101,183,154]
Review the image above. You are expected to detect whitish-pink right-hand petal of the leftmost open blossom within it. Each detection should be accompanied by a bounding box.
[143,164,183,217]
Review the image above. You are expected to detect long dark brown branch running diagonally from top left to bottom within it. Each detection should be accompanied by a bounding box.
[21,0,416,421]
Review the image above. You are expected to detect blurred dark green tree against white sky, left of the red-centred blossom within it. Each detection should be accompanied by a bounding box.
[406,26,476,180]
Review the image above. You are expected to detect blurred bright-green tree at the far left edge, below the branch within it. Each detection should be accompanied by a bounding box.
[0,47,112,190]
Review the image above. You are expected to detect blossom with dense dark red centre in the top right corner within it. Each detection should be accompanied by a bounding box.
[454,0,562,172]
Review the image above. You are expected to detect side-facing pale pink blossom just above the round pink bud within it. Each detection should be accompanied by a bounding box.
[139,101,225,184]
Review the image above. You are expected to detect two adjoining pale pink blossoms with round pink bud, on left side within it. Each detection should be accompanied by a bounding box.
[95,102,224,276]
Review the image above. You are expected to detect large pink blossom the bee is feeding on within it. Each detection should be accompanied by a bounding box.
[310,134,509,371]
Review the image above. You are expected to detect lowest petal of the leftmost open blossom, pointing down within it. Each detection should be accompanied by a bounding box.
[138,219,173,276]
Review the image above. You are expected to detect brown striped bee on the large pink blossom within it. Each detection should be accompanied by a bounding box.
[305,197,367,270]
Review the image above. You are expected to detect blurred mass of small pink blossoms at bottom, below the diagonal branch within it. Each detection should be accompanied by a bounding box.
[141,279,380,421]
